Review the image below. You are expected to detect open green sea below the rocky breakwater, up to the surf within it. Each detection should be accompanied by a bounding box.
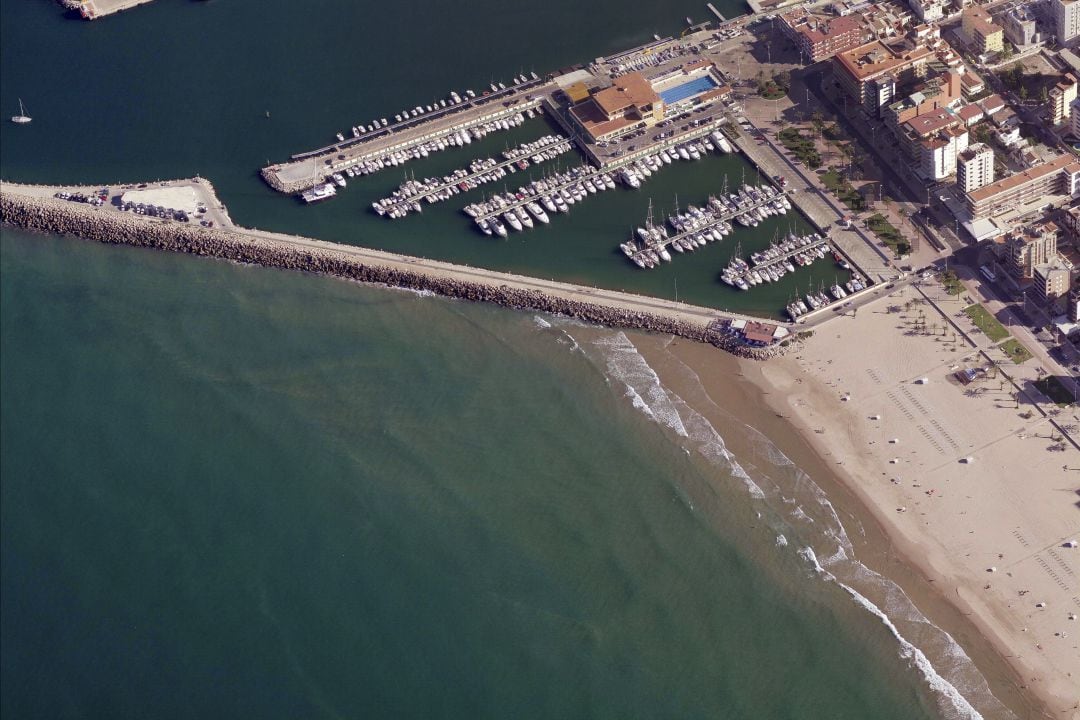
[0,228,993,720]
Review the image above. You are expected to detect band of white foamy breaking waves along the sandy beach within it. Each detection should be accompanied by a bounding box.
[570,331,1015,720]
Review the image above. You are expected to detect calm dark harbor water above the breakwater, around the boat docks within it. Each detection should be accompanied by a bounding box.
[0,0,843,315]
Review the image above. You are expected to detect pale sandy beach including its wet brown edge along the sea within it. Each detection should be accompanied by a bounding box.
[635,280,1080,718]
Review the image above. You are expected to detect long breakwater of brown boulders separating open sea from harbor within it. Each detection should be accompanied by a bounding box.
[0,192,782,359]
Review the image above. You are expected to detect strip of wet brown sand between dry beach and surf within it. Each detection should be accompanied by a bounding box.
[632,336,1067,719]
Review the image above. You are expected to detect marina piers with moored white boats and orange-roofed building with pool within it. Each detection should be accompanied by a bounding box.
[262,21,873,320]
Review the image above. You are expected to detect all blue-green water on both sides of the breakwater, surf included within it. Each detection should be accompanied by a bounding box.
[0,0,1010,720]
